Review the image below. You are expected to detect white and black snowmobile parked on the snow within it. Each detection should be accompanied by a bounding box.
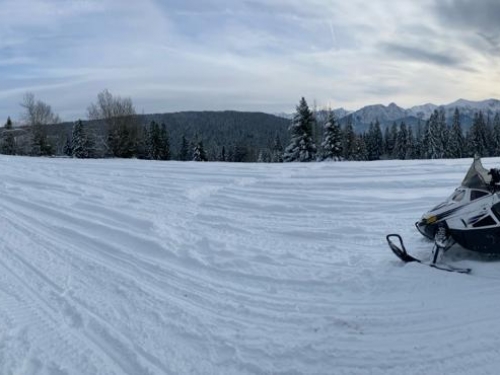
[386,156,500,273]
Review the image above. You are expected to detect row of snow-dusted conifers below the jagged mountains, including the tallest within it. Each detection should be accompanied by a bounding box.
[283,98,500,162]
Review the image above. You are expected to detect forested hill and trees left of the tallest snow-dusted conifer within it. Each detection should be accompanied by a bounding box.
[0,90,289,162]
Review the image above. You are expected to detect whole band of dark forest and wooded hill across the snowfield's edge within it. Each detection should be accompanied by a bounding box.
[0,90,500,162]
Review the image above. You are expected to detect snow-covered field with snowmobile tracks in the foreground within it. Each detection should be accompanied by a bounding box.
[0,156,500,375]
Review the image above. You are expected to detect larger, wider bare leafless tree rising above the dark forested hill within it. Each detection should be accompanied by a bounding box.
[87,90,140,157]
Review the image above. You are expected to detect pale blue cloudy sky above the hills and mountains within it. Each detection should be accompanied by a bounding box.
[0,0,500,122]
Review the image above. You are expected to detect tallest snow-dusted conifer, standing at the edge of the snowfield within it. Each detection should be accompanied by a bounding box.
[284,98,316,162]
